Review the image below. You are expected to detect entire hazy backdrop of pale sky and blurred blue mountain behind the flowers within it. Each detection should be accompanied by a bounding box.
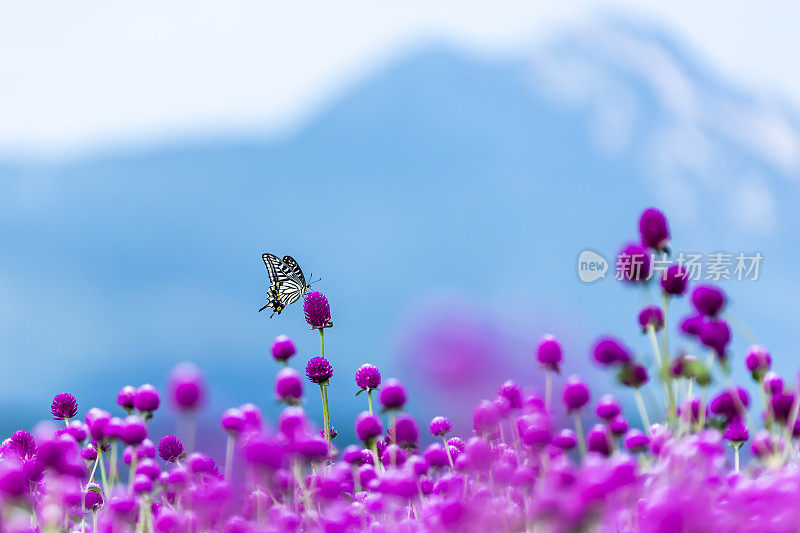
[0,0,800,442]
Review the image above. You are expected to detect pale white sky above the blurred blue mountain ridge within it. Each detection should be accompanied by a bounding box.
[0,0,800,157]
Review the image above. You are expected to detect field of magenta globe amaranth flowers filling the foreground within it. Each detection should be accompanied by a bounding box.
[0,209,800,533]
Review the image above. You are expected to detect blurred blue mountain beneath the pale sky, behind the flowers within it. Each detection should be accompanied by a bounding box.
[0,21,800,433]
